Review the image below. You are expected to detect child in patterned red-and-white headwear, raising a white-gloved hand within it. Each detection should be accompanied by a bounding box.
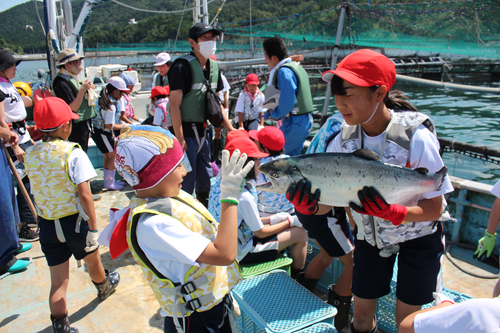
[104,126,253,333]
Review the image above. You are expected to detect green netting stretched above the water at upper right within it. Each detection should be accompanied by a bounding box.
[218,0,500,59]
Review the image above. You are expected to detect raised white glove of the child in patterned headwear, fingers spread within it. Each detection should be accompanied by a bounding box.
[220,149,254,205]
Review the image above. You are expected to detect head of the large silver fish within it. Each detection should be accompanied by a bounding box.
[256,157,302,194]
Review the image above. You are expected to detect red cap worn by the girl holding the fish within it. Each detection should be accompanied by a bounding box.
[321,49,396,90]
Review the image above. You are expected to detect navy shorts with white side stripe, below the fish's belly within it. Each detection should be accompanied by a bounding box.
[295,207,354,258]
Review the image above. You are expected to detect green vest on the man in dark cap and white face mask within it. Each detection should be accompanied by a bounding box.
[180,54,219,123]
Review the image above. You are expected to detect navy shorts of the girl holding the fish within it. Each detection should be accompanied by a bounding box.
[352,222,444,305]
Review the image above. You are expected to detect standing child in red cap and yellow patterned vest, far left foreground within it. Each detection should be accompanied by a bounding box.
[25,97,120,333]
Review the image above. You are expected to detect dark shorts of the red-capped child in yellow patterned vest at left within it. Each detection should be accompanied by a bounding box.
[38,214,97,266]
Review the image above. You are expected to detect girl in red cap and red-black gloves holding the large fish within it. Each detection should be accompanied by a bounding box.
[287,49,453,333]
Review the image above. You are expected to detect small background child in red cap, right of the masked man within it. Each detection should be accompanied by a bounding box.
[234,73,265,131]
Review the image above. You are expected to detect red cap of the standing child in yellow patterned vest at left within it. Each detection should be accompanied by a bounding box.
[33,97,80,132]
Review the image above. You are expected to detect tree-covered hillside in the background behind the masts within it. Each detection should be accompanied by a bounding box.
[0,0,332,53]
